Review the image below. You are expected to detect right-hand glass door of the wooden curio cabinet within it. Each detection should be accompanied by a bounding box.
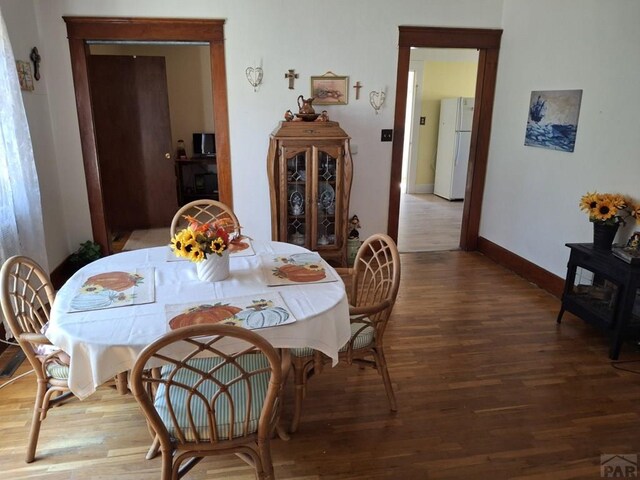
[312,146,342,250]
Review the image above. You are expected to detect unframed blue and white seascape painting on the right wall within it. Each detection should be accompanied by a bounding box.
[524,90,582,152]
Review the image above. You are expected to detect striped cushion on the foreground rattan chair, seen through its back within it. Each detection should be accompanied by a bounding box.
[154,354,271,441]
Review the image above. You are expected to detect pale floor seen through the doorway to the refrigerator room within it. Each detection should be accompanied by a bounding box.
[398,193,463,252]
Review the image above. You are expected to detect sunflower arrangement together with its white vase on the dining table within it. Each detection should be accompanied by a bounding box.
[171,215,231,281]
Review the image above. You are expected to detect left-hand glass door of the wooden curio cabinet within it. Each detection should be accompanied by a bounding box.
[281,147,311,246]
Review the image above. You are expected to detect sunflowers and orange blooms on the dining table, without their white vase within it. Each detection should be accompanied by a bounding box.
[171,215,230,263]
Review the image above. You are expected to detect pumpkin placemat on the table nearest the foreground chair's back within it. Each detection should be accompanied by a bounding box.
[165,292,296,330]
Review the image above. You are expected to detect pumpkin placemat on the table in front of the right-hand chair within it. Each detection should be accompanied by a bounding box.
[260,253,337,287]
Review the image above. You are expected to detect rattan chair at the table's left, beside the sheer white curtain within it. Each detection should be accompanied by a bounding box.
[0,256,73,463]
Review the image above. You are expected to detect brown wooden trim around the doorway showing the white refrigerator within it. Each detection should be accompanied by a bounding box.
[387,26,502,250]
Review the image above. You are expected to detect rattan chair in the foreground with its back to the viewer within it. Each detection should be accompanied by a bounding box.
[131,325,290,480]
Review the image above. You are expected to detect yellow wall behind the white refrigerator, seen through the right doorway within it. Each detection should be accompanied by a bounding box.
[416,62,478,185]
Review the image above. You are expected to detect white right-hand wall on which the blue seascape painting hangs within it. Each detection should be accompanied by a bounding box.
[480,0,640,277]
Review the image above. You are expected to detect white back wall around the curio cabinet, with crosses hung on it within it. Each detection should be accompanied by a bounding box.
[0,0,503,267]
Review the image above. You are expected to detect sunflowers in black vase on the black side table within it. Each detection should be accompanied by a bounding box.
[580,192,640,250]
